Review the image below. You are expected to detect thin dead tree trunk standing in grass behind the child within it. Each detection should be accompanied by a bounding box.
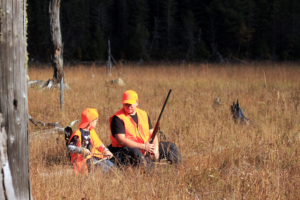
[49,0,64,110]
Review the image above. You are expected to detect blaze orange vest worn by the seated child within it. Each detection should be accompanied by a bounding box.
[68,129,103,174]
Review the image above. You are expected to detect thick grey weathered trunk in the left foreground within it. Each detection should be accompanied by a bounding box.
[0,0,32,200]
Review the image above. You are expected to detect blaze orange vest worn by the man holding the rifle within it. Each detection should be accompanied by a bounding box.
[109,108,151,152]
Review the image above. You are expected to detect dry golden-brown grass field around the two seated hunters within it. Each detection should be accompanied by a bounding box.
[28,62,300,200]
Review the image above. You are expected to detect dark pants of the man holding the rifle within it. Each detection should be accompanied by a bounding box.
[108,142,183,165]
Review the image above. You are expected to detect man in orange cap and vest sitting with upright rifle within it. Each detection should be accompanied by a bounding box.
[108,90,182,165]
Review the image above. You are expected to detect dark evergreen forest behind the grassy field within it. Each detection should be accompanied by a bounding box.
[27,0,300,62]
